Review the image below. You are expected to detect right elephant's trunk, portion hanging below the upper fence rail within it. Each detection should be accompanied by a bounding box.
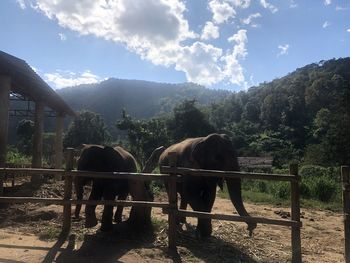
[226,178,257,235]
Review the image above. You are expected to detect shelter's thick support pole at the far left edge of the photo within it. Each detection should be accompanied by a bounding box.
[0,76,11,196]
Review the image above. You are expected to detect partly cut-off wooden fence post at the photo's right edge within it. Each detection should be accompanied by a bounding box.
[341,166,350,263]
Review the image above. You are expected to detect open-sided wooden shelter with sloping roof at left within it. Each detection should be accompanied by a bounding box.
[0,51,75,195]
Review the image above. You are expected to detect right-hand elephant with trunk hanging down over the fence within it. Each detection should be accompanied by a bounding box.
[159,133,257,238]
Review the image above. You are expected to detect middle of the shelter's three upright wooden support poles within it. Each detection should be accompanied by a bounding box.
[31,101,44,182]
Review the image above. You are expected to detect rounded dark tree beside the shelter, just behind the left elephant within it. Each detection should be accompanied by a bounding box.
[63,111,110,147]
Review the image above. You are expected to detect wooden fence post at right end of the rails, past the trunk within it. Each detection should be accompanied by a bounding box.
[289,164,301,263]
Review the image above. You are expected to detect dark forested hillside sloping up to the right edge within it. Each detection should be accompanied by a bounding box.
[210,58,350,165]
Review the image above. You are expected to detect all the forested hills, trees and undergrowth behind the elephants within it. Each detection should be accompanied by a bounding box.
[6,58,350,210]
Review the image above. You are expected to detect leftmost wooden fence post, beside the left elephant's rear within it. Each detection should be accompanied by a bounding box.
[62,148,74,233]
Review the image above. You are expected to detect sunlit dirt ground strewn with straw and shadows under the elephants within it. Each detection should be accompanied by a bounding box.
[0,178,344,263]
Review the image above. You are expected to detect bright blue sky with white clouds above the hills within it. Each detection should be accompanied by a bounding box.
[0,0,350,91]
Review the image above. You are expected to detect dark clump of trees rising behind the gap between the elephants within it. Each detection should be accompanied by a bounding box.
[117,100,214,164]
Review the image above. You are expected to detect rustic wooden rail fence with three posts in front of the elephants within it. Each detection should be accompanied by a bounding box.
[0,149,302,262]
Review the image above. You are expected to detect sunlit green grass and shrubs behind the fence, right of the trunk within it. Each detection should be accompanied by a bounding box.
[219,165,342,210]
